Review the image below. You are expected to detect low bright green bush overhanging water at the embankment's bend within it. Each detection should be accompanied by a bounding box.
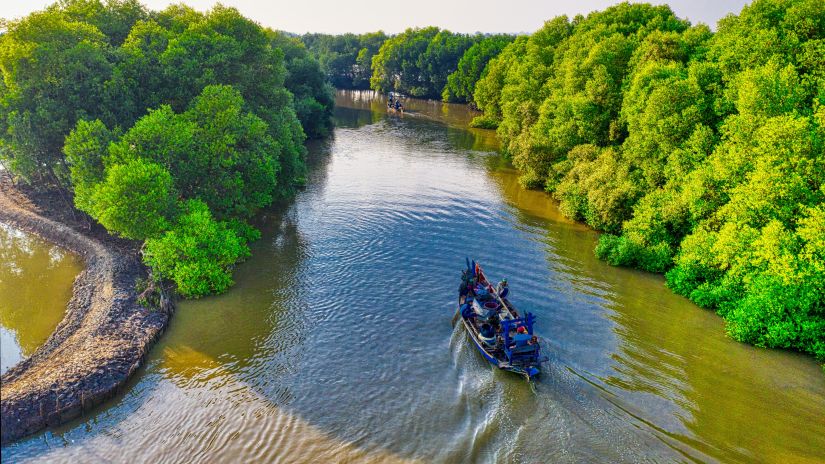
[143,200,249,298]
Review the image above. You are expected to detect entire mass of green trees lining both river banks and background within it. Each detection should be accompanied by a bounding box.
[0,0,825,359]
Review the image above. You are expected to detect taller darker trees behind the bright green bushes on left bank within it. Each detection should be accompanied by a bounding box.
[0,0,333,195]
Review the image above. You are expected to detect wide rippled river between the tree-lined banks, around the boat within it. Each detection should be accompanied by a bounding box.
[3,92,825,463]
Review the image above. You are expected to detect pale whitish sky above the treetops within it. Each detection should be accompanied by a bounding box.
[0,0,749,34]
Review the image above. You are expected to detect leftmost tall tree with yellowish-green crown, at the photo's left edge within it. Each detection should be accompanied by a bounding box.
[0,9,112,183]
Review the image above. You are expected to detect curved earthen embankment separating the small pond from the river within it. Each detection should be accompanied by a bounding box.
[0,174,172,444]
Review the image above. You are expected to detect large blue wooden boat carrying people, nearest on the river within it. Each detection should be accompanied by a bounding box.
[457,258,547,381]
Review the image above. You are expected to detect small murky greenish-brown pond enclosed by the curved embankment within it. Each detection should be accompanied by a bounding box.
[0,224,81,372]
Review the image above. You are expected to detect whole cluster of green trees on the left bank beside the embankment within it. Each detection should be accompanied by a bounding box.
[0,0,332,296]
